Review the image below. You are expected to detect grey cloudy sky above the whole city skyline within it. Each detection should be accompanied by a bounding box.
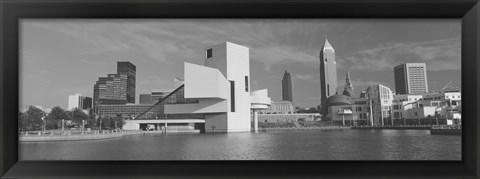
[19,19,461,109]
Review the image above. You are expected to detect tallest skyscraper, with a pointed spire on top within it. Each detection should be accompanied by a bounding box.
[320,37,337,103]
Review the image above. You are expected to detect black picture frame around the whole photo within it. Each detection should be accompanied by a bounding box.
[0,0,480,178]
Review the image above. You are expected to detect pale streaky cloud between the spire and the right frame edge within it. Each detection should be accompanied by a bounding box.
[337,38,461,71]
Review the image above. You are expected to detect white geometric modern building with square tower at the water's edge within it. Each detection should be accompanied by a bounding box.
[126,42,270,132]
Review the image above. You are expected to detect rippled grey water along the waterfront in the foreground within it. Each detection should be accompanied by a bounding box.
[19,130,461,160]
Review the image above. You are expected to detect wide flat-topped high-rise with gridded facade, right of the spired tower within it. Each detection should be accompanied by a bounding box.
[393,63,428,94]
